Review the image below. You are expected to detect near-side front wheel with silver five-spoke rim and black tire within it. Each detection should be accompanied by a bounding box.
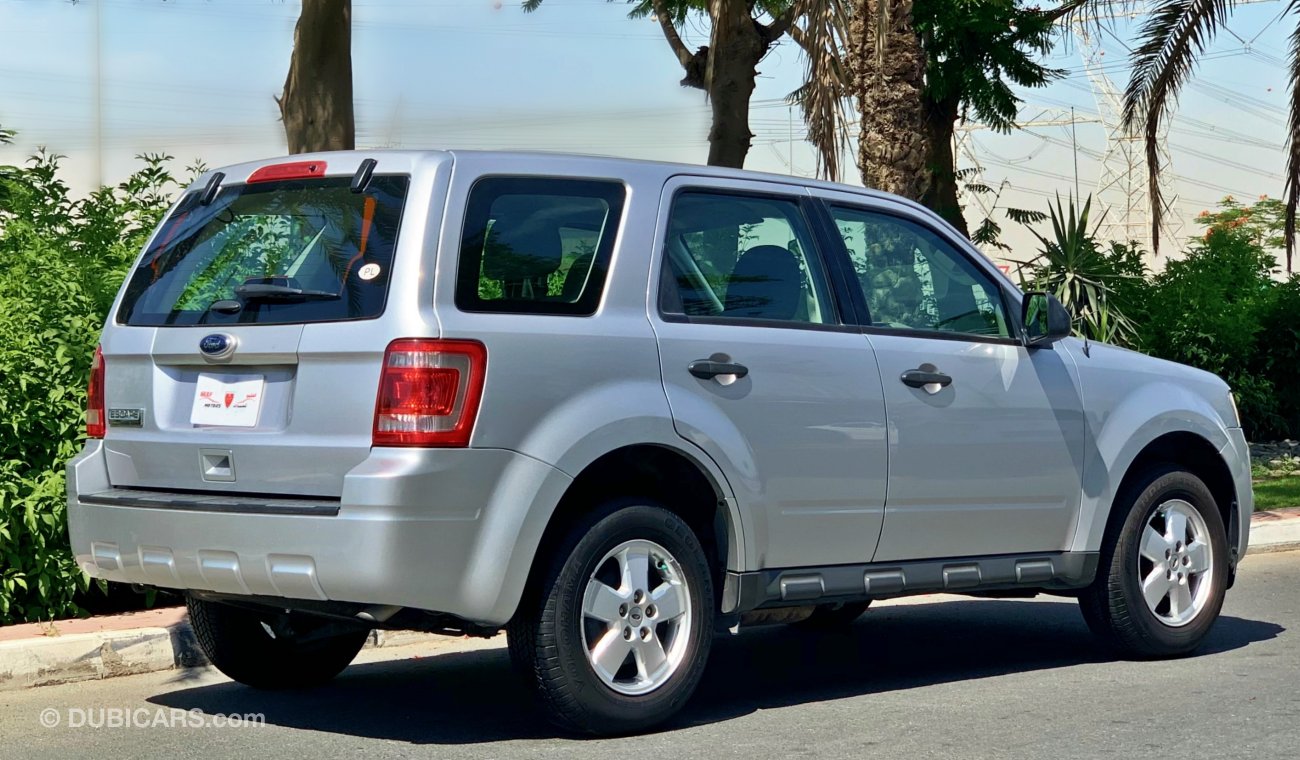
[1079,466,1229,659]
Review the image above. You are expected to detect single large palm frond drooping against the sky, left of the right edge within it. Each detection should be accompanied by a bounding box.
[1123,0,1235,253]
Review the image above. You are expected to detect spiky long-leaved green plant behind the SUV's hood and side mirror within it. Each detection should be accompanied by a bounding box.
[1019,196,1144,346]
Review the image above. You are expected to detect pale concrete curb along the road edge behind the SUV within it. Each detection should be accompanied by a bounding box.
[0,509,1300,691]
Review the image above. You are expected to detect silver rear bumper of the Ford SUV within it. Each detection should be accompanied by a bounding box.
[68,442,571,625]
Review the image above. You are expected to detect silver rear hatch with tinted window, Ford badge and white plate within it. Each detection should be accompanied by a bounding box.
[103,161,411,498]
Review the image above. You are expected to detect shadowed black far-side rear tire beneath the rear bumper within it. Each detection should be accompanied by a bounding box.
[186,596,369,689]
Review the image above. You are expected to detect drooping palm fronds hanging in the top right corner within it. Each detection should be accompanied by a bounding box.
[1125,0,1300,272]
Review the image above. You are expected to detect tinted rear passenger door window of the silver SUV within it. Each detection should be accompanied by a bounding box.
[660,191,837,325]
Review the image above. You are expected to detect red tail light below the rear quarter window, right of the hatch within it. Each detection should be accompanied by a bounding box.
[372,338,488,447]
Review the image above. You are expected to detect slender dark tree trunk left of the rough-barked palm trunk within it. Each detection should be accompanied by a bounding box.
[705,0,770,169]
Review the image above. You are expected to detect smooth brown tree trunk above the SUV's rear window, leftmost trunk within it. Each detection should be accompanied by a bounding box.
[276,0,356,153]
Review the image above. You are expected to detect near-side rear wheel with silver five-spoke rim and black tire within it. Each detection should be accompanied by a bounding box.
[507,500,714,734]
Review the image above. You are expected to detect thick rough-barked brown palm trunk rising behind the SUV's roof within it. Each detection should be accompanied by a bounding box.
[849,0,933,200]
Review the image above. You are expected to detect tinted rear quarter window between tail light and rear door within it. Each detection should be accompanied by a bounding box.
[456,177,625,316]
